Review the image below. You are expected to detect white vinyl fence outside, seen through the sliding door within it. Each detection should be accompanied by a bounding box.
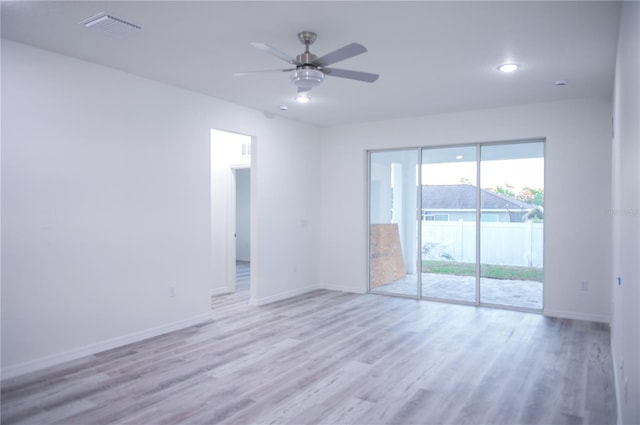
[422,221,543,267]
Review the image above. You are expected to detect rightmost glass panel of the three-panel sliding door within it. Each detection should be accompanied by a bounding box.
[480,142,544,310]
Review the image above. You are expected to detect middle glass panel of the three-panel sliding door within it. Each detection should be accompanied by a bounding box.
[421,146,478,303]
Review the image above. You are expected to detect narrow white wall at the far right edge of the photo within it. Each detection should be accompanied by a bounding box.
[609,2,640,424]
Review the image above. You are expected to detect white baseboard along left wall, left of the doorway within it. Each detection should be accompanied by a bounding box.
[2,313,213,380]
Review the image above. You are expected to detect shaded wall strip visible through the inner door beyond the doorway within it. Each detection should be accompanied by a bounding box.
[236,168,251,261]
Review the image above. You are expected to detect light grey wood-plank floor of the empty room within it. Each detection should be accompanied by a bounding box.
[2,282,616,425]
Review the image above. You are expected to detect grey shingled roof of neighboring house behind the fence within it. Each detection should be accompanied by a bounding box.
[422,184,534,211]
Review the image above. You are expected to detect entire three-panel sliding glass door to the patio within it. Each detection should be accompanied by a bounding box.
[368,140,544,310]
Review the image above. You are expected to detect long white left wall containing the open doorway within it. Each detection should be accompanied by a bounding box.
[2,40,319,378]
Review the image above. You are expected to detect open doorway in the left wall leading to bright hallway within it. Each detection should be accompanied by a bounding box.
[210,129,251,300]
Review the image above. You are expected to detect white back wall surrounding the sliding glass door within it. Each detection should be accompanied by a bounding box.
[320,100,612,321]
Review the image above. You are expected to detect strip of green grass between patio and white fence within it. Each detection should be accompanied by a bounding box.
[422,261,542,282]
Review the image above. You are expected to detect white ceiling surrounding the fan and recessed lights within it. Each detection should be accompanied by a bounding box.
[1,1,620,126]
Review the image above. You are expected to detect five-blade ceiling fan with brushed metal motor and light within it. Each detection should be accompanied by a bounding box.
[234,31,379,93]
